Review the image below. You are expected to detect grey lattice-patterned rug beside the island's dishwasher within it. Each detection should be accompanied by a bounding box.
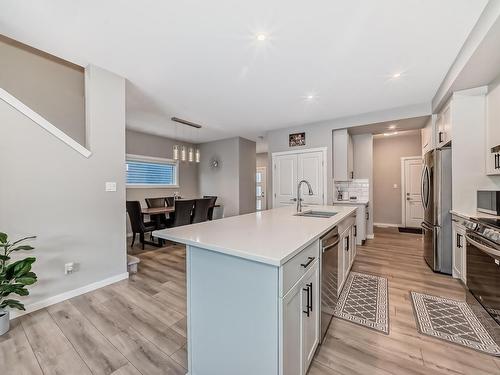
[335,272,389,335]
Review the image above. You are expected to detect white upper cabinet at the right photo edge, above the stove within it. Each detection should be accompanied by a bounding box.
[486,81,500,175]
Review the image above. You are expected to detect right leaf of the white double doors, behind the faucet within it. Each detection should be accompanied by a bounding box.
[297,151,325,204]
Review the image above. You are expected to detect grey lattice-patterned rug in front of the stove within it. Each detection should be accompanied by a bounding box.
[410,292,500,356]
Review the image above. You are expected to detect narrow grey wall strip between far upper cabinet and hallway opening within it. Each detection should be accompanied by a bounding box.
[352,134,373,236]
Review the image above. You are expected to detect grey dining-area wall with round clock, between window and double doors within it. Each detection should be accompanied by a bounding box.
[198,137,256,217]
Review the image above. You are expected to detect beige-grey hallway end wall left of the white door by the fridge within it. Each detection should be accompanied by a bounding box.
[373,132,422,225]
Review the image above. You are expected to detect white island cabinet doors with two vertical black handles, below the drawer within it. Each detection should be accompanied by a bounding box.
[281,261,320,375]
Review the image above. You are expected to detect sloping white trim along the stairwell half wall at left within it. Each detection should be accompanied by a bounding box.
[0,88,92,158]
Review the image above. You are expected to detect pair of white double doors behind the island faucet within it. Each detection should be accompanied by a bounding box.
[273,151,326,207]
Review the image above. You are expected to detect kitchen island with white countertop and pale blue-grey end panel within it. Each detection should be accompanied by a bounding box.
[153,206,356,375]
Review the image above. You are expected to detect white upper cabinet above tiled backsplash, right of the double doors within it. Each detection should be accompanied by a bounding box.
[333,129,354,181]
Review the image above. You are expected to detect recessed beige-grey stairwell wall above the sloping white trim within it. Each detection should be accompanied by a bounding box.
[0,35,85,145]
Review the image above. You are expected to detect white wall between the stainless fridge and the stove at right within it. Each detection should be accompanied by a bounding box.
[451,87,500,215]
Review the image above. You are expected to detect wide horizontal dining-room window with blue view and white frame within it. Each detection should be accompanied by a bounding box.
[126,155,178,188]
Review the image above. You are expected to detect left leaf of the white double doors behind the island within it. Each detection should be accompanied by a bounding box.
[273,154,297,207]
